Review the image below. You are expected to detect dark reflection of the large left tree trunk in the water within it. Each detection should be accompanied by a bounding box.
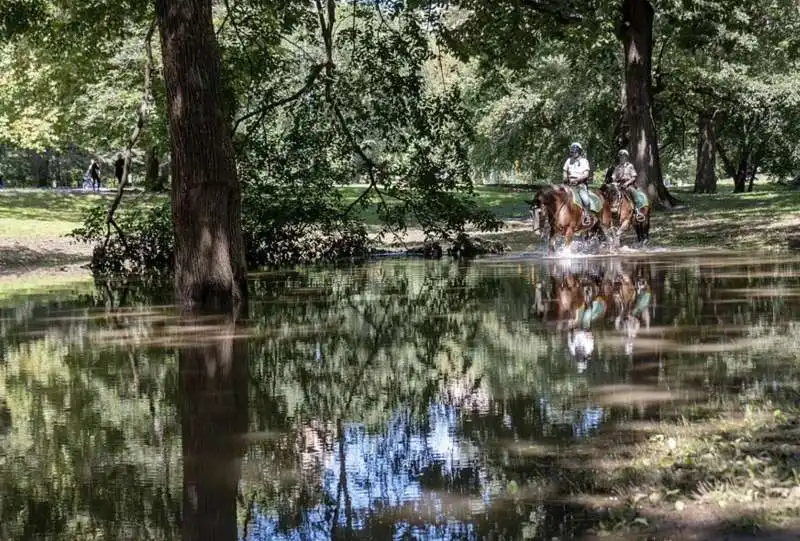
[178,314,248,541]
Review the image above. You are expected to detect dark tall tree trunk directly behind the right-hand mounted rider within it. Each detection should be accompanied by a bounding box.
[619,0,677,208]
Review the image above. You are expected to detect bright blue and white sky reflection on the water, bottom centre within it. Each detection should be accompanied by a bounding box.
[248,401,604,541]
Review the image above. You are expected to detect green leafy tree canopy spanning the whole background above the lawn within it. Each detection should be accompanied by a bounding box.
[0,0,800,274]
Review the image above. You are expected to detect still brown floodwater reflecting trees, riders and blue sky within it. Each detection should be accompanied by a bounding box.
[0,255,800,540]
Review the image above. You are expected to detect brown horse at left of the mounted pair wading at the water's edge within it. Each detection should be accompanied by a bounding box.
[527,184,612,253]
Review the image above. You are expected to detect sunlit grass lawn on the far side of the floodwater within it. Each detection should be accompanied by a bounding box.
[0,181,800,251]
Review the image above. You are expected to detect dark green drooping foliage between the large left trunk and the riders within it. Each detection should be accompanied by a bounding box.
[229,1,498,243]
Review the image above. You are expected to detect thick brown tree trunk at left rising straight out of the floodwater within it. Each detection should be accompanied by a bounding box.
[156,0,247,311]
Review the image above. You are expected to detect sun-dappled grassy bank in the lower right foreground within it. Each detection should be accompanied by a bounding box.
[540,402,800,541]
